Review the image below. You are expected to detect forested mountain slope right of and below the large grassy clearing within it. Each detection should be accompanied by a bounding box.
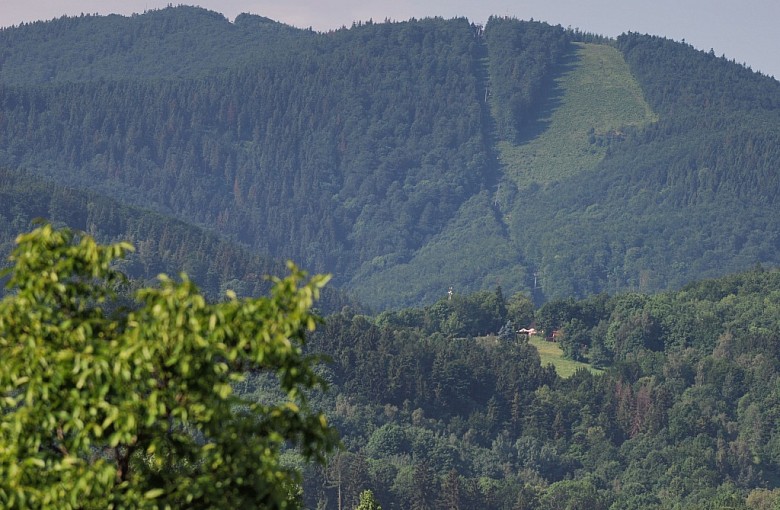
[508,35,780,297]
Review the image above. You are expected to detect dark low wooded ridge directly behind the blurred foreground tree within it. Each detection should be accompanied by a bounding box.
[0,168,361,313]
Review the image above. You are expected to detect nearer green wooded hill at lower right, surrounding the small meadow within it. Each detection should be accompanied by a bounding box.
[288,268,780,510]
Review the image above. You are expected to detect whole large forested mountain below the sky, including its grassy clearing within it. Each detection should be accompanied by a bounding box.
[0,7,780,309]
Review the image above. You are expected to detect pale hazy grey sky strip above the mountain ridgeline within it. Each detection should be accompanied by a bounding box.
[0,0,780,79]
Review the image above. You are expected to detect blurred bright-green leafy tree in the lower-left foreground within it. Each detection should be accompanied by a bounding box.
[0,225,337,509]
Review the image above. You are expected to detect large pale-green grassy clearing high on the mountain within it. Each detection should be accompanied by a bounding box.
[498,43,657,188]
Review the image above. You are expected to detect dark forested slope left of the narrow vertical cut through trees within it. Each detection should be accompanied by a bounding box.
[0,11,491,298]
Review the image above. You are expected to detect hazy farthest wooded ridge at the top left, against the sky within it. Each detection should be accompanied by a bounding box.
[0,6,314,85]
